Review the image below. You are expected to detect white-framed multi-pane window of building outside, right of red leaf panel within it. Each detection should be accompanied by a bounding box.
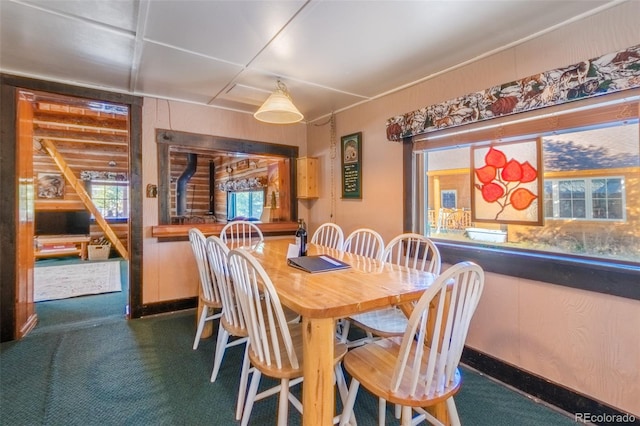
[544,177,625,220]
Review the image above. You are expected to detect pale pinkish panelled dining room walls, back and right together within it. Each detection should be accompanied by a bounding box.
[142,1,640,416]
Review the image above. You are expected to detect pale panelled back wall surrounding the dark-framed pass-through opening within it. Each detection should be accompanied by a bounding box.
[142,98,307,303]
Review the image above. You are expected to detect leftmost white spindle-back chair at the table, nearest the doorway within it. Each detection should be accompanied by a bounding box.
[189,228,222,350]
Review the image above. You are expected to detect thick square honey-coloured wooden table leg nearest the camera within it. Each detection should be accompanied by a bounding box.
[302,317,335,426]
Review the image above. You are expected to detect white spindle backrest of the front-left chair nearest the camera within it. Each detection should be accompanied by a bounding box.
[228,248,300,368]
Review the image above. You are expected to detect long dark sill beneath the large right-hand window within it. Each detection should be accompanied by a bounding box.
[433,238,640,300]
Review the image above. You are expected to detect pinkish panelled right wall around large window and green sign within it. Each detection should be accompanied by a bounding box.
[307,1,640,415]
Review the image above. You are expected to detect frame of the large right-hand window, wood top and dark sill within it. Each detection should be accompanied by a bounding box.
[402,89,640,300]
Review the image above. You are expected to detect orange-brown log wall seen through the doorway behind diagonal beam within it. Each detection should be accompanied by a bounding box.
[33,93,129,247]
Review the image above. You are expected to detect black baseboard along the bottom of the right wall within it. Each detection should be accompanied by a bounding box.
[461,346,640,425]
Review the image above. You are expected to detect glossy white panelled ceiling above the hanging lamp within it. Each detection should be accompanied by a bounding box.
[0,0,620,121]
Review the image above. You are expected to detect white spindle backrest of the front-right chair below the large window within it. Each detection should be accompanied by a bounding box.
[391,262,484,397]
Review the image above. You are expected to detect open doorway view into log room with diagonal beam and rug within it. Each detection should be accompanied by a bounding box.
[28,89,130,332]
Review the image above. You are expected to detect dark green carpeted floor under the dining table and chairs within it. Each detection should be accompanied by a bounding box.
[0,264,574,426]
